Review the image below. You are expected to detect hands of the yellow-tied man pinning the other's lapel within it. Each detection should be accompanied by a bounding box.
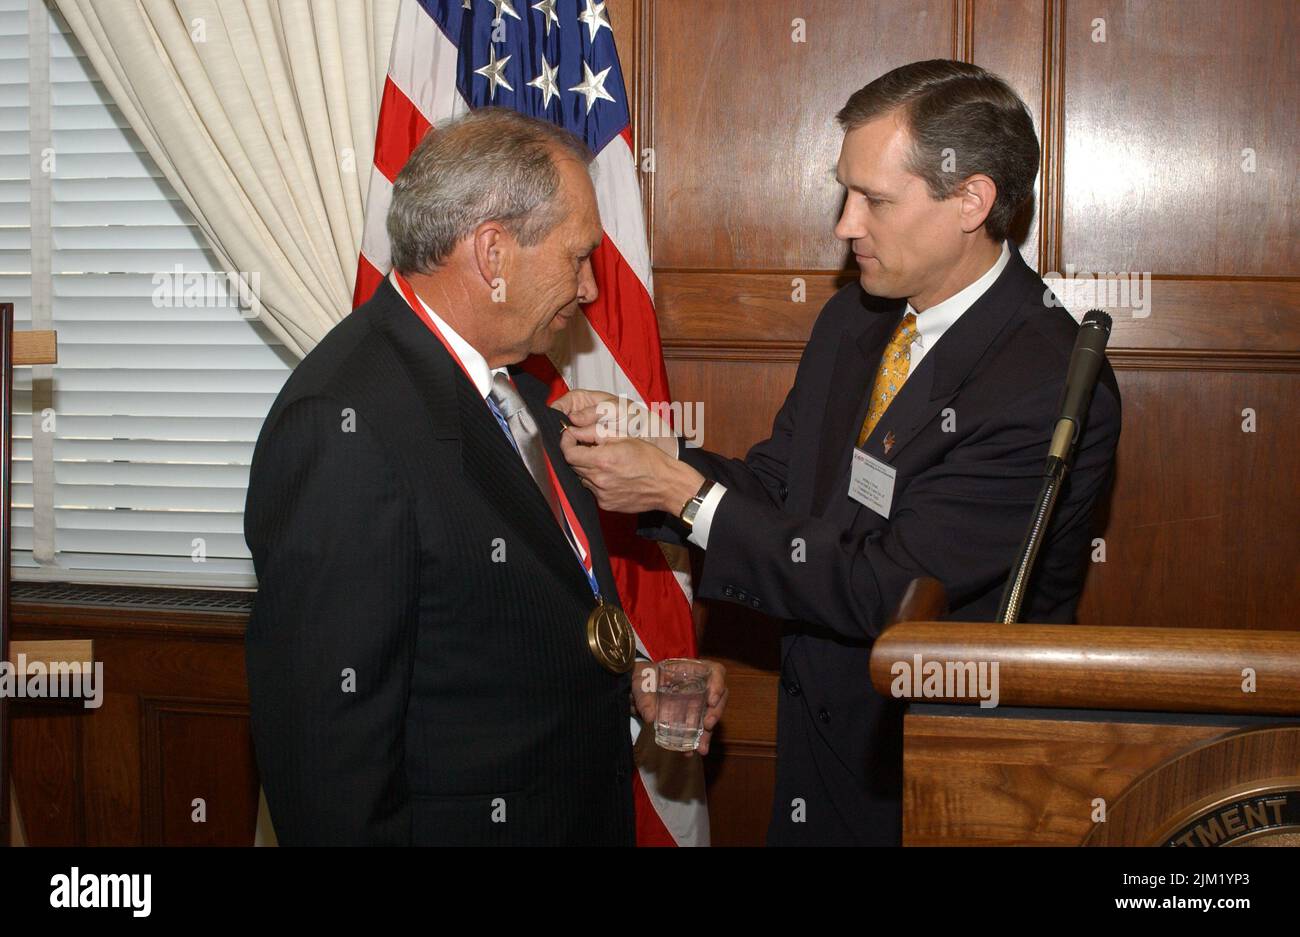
[560,425,705,517]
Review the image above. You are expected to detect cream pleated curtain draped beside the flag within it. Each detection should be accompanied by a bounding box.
[52,0,399,356]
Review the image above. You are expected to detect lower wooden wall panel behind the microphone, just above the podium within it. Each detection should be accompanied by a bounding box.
[1079,368,1300,629]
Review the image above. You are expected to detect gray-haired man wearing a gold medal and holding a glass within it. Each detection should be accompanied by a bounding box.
[244,108,727,845]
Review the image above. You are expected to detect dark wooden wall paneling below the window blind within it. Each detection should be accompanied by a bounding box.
[12,600,257,846]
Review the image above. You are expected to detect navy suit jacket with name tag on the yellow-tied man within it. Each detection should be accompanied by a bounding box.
[644,247,1119,845]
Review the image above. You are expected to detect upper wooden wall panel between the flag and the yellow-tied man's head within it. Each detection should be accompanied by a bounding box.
[649,0,954,270]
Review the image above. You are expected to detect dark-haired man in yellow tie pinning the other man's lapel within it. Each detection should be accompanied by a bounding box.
[555,61,1119,845]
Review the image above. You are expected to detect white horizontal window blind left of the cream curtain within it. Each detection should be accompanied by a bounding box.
[0,0,294,587]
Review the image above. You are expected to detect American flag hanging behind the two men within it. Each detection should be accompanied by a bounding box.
[352,0,709,846]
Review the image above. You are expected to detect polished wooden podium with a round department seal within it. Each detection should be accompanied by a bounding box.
[871,581,1300,846]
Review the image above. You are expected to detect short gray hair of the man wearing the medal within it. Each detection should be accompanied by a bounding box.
[387,108,593,274]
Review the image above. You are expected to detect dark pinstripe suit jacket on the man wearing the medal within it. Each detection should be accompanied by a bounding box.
[244,281,633,845]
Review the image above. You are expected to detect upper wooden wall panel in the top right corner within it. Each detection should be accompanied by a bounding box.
[1058,0,1300,275]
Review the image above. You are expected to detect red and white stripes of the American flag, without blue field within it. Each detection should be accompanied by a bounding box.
[352,0,709,846]
